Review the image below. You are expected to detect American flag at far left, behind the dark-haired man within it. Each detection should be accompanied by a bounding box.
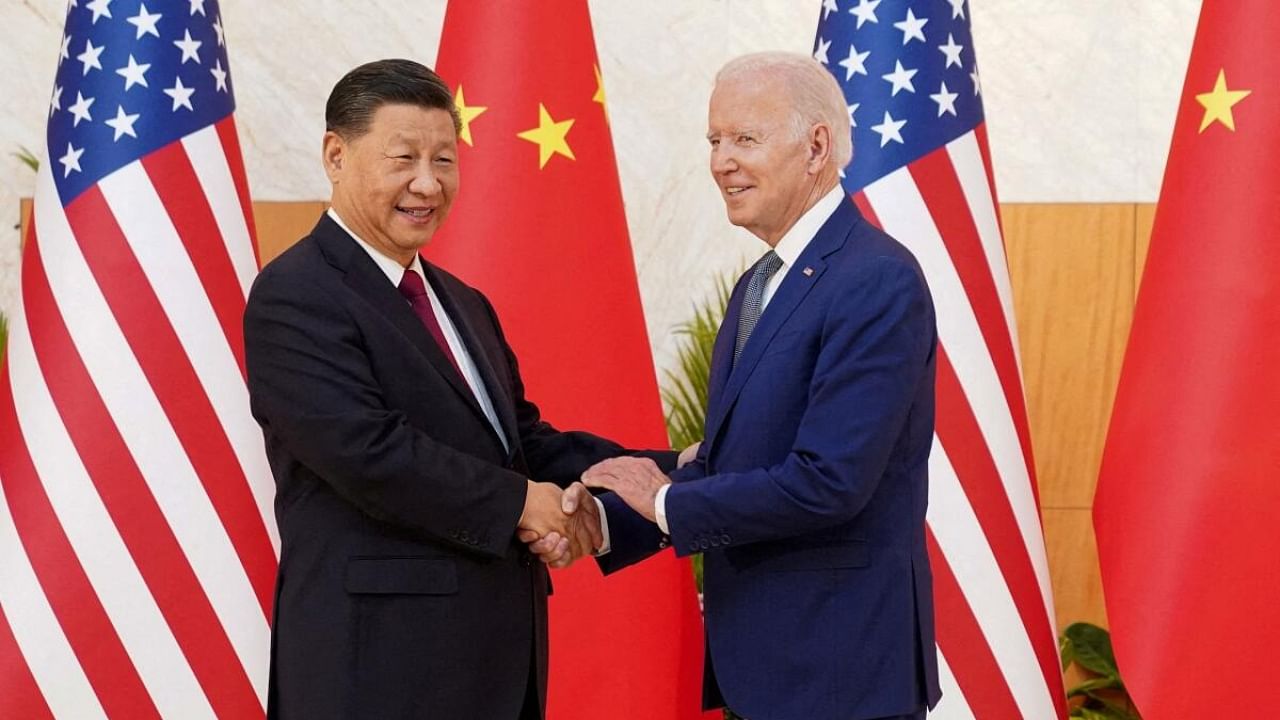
[0,0,272,719]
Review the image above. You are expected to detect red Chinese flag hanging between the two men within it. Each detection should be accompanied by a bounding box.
[429,0,703,720]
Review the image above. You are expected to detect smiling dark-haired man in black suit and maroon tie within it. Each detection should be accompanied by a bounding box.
[244,60,655,720]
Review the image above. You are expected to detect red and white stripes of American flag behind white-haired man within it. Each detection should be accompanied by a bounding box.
[854,126,1065,719]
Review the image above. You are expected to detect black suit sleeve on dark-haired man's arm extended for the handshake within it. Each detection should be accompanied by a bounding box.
[244,266,526,556]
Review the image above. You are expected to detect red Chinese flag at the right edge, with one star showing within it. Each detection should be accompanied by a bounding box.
[1093,0,1280,720]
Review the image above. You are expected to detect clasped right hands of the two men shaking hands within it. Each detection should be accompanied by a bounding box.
[516,480,604,568]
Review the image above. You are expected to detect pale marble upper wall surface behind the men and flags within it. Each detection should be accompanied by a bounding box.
[0,0,1199,376]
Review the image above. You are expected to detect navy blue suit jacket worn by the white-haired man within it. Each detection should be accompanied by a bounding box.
[604,197,940,720]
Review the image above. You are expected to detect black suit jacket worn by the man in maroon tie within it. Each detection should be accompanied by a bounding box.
[244,217,650,720]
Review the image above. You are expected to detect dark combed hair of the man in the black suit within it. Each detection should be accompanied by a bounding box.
[324,59,462,138]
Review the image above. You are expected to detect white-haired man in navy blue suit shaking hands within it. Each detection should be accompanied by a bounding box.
[576,54,940,720]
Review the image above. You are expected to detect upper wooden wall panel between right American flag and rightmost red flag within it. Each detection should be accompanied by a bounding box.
[1001,204,1134,507]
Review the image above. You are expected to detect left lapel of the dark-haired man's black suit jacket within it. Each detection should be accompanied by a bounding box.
[311,214,489,435]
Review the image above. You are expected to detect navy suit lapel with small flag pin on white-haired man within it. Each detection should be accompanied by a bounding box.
[704,200,861,450]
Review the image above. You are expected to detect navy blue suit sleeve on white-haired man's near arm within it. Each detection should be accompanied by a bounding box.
[665,258,936,555]
